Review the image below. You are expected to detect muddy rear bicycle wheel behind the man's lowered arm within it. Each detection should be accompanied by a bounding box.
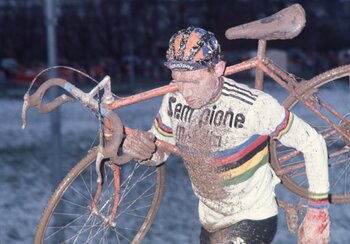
[270,65,350,203]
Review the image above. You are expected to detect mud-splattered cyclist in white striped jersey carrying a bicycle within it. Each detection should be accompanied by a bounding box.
[123,27,329,243]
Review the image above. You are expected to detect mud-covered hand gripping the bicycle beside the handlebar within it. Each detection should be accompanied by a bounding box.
[122,130,156,162]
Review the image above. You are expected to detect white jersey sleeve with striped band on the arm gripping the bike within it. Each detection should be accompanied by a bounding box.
[150,94,175,165]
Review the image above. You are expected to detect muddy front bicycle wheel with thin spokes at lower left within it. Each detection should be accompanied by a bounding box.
[34,149,165,244]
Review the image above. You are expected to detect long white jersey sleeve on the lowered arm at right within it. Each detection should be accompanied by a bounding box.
[247,94,329,200]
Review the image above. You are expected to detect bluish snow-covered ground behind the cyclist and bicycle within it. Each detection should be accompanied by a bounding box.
[0,81,350,244]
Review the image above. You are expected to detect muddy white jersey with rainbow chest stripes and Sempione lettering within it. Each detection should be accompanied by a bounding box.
[151,77,329,231]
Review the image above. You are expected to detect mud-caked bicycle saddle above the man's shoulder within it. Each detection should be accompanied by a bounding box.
[225,4,306,40]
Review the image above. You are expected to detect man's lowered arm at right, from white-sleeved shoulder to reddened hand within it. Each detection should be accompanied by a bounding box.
[248,95,330,243]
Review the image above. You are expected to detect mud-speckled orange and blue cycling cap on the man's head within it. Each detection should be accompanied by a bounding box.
[164,27,221,71]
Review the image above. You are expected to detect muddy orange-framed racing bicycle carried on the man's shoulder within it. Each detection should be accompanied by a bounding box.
[22,4,350,243]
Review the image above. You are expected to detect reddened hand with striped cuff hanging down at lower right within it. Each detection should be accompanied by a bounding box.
[298,200,330,244]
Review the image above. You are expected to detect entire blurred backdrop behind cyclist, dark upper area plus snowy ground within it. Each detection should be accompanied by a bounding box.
[0,0,350,244]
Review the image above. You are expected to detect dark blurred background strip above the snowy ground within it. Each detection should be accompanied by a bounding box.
[0,0,350,89]
